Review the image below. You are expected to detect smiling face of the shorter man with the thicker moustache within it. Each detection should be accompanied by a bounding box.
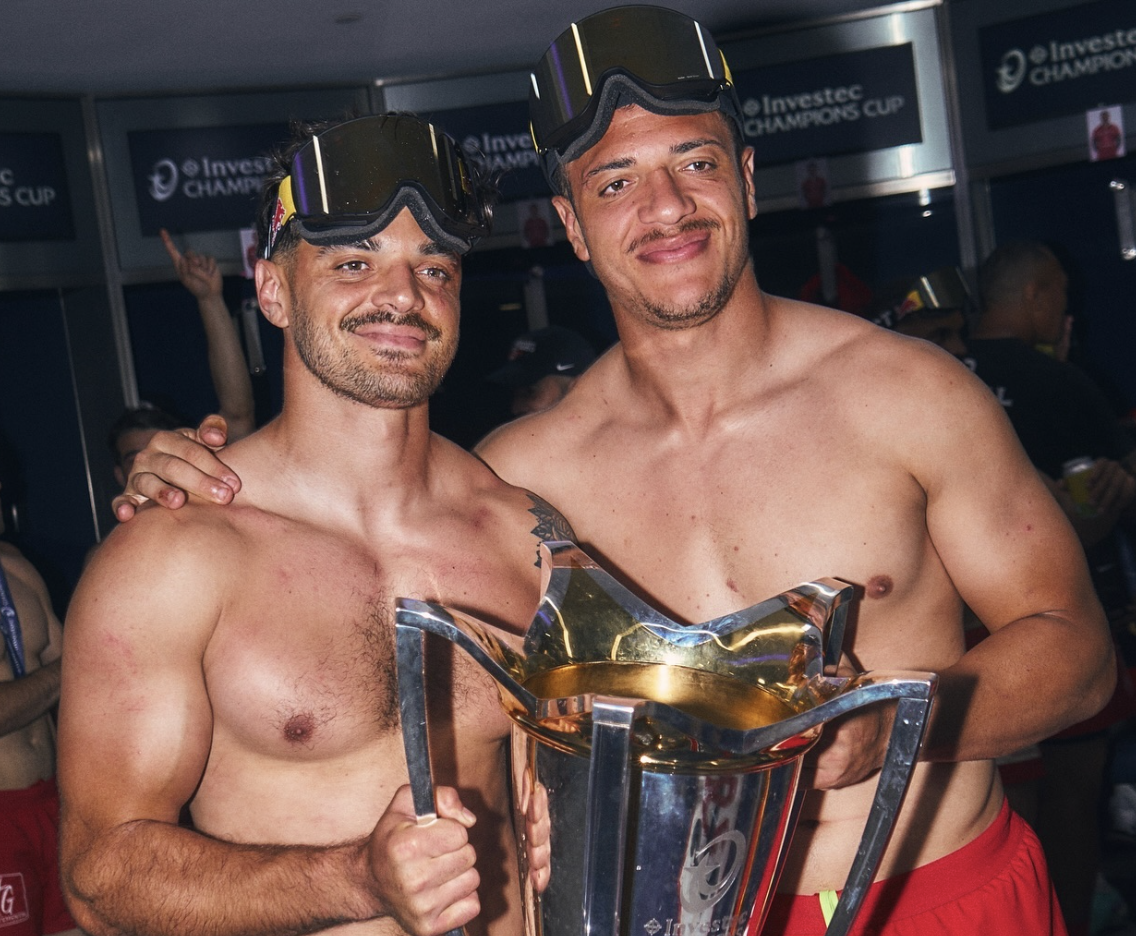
[257,209,461,408]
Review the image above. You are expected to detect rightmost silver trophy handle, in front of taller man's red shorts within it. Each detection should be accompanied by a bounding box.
[825,682,934,936]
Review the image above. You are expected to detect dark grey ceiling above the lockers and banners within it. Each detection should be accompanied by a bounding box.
[0,0,913,95]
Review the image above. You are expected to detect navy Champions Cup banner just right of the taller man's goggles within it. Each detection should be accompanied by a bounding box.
[734,43,922,166]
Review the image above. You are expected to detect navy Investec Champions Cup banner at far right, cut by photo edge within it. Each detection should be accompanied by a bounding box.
[978,0,1136,129]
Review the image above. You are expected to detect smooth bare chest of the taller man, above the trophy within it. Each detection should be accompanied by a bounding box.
[540,427,946,645]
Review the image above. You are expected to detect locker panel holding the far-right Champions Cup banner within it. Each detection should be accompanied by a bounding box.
[951,0,1136,167]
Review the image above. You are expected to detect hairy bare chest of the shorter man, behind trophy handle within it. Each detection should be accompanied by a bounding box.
[206,543,535,762]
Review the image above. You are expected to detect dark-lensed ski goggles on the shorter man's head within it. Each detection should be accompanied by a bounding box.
[261,115,493,259]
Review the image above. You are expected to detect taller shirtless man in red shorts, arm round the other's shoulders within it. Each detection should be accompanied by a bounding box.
[118,7,1113,936]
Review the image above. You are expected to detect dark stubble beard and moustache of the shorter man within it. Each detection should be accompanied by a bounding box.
[292,302,458,409]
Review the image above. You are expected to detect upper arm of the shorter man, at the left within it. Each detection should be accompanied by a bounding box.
[59,529,222,828]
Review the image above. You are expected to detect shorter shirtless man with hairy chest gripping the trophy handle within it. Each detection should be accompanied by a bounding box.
[59,116,563,936]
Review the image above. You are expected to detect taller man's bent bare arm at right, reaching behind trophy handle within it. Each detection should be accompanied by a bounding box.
[907,354,1113,760]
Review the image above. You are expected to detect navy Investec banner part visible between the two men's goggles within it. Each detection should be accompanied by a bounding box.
[423,101,550,202]
